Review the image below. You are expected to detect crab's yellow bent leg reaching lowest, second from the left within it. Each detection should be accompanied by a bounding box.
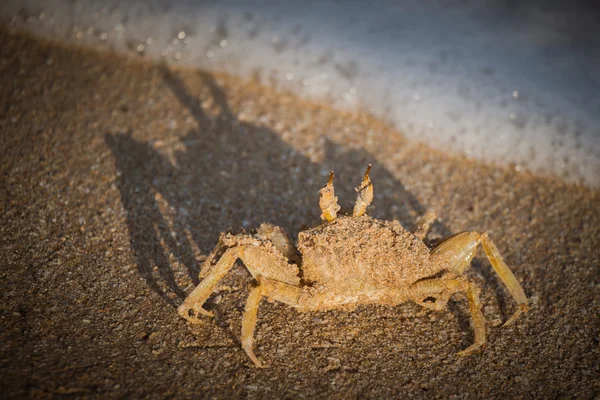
[242,279,301,368]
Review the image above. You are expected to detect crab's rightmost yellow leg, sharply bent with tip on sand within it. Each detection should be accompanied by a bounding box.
[431,232,529,325]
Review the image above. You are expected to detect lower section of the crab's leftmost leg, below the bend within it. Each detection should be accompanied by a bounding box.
[177,247,242,322]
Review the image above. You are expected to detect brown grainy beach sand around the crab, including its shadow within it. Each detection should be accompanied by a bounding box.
[0,30,600,398]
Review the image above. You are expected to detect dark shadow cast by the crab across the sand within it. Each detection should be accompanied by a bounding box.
[105,66,492,350]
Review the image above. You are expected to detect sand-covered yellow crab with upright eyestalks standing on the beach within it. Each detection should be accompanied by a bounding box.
[178,165,528,367]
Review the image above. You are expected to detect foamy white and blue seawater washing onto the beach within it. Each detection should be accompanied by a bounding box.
[0,0,600,187]
